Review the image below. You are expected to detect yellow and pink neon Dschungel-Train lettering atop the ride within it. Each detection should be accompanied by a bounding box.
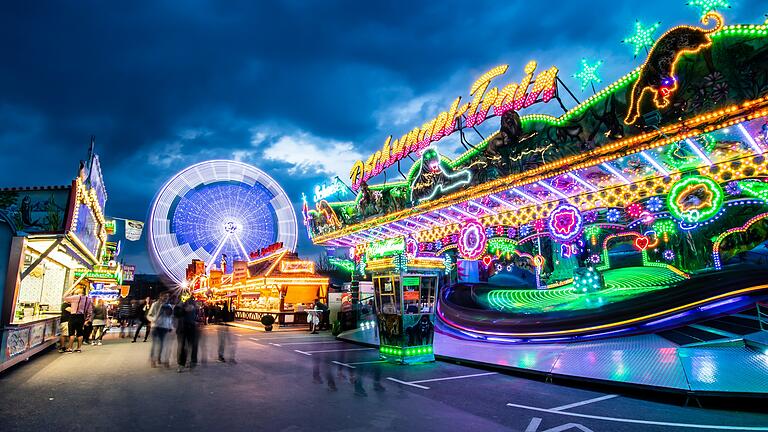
[349,61,557,191]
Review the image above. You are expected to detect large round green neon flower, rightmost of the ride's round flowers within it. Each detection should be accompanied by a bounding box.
[667,175,725,223]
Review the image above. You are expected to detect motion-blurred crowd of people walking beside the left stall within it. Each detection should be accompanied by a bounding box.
[59,288,235,372]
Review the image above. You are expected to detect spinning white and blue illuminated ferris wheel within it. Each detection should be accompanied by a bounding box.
[148,160,298,283]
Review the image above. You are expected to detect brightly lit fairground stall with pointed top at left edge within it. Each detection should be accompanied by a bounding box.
[0,147,107,370]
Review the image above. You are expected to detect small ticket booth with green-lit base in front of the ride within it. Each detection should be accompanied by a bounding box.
[372,258,443,364]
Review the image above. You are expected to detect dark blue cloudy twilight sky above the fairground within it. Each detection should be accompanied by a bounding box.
[0,0,768,272]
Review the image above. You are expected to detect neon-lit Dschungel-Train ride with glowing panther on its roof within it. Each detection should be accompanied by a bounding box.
[303,13,768,344]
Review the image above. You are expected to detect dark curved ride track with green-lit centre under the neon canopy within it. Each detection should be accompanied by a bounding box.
[437,267,768,342]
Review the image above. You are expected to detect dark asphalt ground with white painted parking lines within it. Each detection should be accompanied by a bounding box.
[0,326,768,432]
